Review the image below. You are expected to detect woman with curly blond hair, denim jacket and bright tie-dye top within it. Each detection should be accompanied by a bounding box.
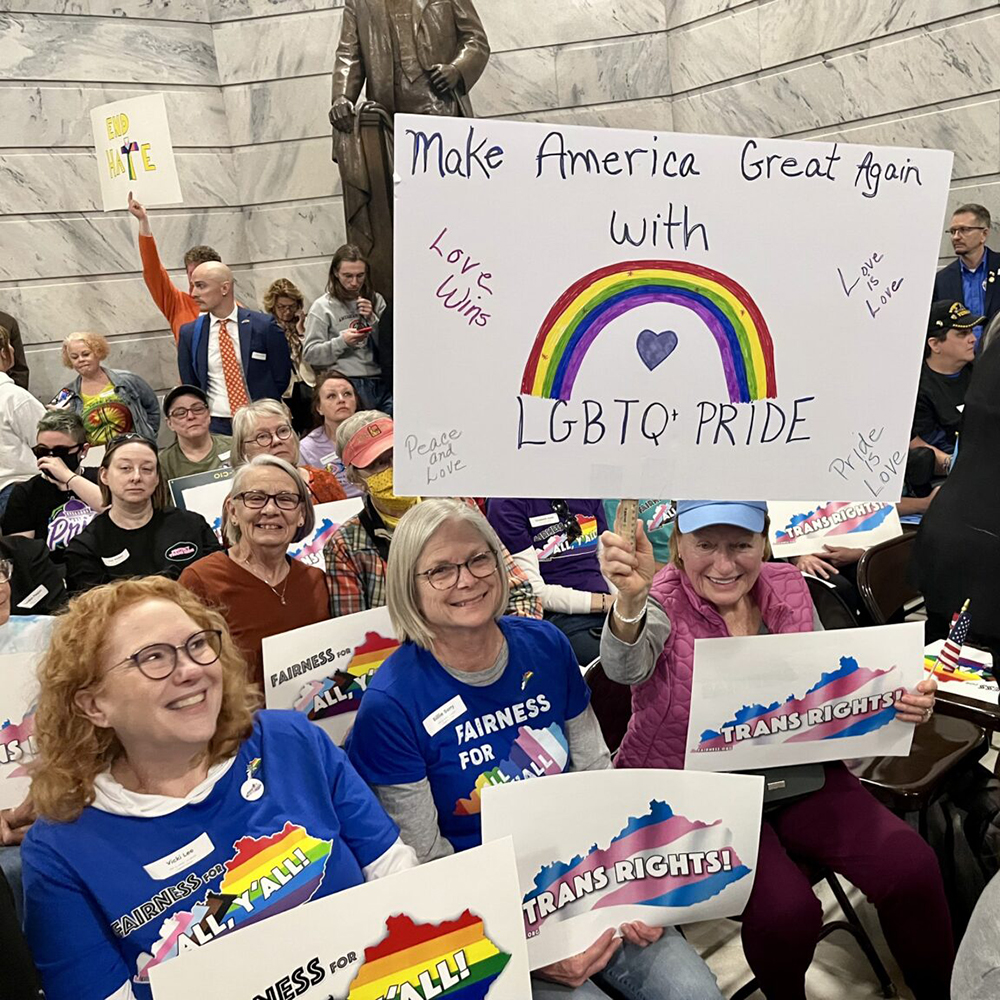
[49,333,160,444]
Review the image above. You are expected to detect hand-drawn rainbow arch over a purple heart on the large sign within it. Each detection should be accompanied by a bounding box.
[521,260,778,403]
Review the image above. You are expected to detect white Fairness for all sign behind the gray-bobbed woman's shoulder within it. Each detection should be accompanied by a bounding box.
[262,608,399,743]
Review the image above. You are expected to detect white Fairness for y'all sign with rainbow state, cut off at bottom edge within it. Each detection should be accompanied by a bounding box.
[150,840,531,1000]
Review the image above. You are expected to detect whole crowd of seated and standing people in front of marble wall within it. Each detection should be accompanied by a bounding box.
[0,199,1000,1000]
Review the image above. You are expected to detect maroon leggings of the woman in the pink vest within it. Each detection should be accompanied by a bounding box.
[742,763,955,1000]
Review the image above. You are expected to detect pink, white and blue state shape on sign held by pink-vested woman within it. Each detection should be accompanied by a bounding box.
[692,656,904,753]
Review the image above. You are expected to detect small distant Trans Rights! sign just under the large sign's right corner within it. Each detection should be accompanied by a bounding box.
[767,500,903,559]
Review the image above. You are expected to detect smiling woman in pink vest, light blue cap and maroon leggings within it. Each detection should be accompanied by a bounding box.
[601,500,954,1000]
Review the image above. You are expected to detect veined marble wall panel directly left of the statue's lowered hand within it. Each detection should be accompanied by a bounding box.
[222,73,331,146]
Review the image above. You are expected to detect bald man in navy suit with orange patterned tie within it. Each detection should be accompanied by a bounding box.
[177,261,292,434]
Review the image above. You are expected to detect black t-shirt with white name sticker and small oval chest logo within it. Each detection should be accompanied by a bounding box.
[66,508,222,594]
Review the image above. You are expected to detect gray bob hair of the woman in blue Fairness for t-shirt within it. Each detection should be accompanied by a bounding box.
[386,497,510,649]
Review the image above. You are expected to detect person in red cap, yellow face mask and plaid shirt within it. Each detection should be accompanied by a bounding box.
[323,410,542,618]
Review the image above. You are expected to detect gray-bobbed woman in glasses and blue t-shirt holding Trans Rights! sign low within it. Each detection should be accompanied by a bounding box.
[347,499,720,1000]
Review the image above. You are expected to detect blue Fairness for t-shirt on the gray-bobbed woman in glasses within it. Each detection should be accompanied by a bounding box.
[347,618,590,851]
